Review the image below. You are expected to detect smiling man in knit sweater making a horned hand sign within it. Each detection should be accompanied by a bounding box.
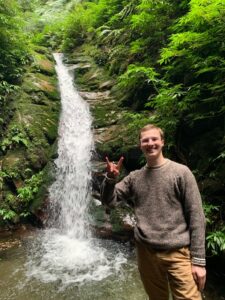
[102,124,206,300]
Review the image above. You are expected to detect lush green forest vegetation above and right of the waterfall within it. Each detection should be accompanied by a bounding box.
[0,0,225,254]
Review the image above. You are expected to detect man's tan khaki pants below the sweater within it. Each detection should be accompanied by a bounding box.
[137,243,202,300]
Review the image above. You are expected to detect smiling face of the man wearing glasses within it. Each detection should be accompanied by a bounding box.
[140,129,164,159]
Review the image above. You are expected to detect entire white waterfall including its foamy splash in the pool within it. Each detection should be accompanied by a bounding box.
[27,54,126,286]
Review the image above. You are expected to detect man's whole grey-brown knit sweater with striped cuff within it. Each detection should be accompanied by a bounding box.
[101,159,205,266]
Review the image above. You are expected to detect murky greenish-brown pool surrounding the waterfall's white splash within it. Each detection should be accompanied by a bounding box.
[0,234,225,300]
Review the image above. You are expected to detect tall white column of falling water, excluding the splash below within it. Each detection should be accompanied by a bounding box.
[50,54,93,239]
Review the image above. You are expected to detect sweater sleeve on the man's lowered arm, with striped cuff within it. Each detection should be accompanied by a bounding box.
[181,168,205,266]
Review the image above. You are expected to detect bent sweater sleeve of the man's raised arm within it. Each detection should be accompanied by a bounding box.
[101,175,131,207]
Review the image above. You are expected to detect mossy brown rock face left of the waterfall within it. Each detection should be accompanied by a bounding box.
[0,49,60,225]
